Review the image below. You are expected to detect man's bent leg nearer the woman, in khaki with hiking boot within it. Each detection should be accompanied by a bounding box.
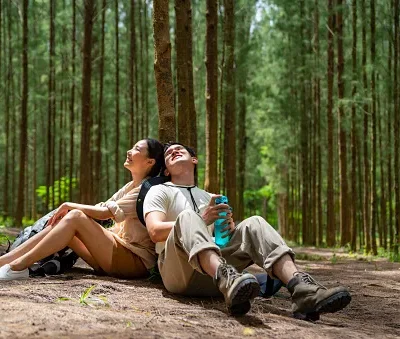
[159,210,259,314]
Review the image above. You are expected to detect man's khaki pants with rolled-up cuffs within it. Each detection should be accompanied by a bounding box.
[158,210,294,296]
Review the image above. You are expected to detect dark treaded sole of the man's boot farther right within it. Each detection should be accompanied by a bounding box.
[293,291,351,321]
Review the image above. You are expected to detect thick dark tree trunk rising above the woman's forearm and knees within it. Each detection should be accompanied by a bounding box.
[79,0,95,204]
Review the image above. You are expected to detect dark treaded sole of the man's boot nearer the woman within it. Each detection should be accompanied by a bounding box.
[228,279,260,316]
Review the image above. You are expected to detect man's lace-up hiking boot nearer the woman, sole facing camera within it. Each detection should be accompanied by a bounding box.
[214,262,260,315]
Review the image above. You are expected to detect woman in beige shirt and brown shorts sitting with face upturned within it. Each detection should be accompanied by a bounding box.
[0,139,164,280]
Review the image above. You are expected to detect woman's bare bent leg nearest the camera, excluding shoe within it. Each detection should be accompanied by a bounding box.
[10,210,115,272]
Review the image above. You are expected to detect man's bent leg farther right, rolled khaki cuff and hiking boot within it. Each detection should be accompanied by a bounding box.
[222,217,351,320]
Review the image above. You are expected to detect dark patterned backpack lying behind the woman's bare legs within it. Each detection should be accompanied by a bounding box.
[6,210,79,276]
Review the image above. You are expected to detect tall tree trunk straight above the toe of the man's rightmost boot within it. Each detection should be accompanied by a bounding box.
[337,0,350,246]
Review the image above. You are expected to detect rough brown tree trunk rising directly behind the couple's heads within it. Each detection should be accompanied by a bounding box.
[153,0,176,142]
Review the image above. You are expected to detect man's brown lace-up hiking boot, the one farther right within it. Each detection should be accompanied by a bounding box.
[287,272,351,321]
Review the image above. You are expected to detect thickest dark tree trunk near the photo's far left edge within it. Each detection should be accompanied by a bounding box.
[15,0,28,226]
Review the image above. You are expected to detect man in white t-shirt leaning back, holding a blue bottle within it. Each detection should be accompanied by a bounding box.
[144,143,351,320]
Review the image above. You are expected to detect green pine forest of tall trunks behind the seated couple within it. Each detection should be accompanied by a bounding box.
[0,0,400,260]
